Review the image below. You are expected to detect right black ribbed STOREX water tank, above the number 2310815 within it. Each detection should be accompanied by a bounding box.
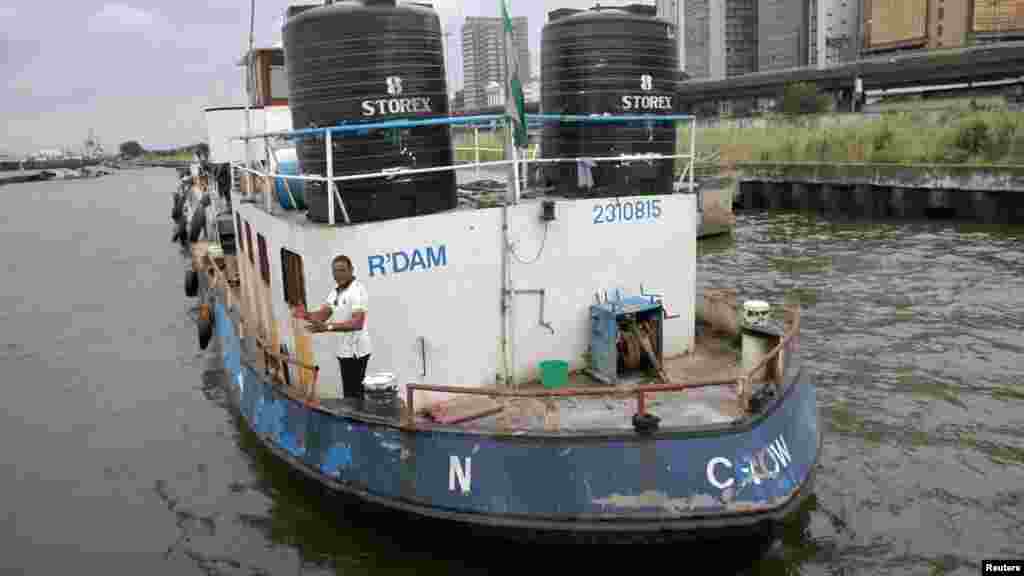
[541,8,679,197]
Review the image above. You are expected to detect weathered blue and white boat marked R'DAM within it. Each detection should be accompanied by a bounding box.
[174,0,821,541]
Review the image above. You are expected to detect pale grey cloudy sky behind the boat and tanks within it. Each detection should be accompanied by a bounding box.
[0,0,638,155]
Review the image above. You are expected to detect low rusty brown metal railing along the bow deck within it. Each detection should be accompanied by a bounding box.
[402,305,800,429]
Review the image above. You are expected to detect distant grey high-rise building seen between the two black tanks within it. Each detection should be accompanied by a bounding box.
[462,16,530,110]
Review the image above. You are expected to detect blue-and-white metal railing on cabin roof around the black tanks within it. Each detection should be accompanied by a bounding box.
[231,114,696,225]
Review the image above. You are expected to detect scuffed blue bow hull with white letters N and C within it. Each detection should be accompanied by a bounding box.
[214,295,821,533]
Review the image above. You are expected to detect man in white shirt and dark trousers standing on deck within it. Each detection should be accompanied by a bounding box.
[298,254,373,400]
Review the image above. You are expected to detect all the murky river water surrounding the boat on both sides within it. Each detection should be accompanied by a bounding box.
[0,169,1024,575]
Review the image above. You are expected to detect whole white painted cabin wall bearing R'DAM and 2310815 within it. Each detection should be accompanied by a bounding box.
[236,195,696,406]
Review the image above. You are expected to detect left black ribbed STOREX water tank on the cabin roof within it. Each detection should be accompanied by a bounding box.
[283,0,456,222]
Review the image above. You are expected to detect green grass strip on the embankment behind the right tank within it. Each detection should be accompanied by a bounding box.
[678,109,1024,164]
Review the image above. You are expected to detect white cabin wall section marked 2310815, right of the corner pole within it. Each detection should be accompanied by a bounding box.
[498,195,696,380]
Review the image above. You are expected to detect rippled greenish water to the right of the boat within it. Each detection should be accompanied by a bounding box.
[698,212,1024,574]
